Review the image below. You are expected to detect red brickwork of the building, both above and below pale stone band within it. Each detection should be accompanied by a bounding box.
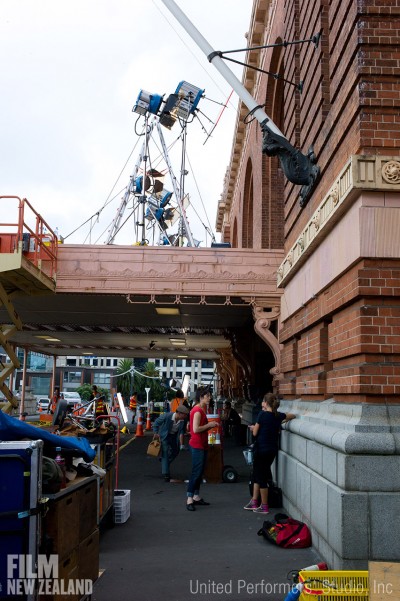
[222,0,400,402]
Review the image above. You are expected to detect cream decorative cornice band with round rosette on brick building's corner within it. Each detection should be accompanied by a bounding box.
[277,155,400,287]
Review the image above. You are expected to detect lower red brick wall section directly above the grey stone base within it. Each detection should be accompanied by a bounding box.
[279,259,400,403]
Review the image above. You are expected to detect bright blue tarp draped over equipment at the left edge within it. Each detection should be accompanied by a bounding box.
[0,411,96,462]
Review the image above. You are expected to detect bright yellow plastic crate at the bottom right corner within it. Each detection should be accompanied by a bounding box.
[299,570,369,601]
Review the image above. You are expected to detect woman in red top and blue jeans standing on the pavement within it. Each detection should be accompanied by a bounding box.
[186,386,218,511]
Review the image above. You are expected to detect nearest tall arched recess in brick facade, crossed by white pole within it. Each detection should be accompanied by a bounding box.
[261,39,285,249]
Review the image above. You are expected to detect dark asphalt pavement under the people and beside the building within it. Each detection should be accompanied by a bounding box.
[92,432,320,601]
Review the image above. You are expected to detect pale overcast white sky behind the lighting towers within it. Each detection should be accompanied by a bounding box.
[0,0,253,246]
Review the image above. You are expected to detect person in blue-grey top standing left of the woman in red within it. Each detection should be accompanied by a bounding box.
[153,405,189,482]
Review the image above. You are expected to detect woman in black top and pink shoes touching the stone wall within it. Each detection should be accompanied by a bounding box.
[244,393,296,513]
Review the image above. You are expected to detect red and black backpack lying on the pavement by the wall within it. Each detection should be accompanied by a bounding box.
[257,513,311,549]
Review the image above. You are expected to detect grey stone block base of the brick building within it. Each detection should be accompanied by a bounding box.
[278,400,400,569]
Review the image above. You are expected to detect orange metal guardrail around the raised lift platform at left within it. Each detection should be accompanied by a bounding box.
[0,195,58,279]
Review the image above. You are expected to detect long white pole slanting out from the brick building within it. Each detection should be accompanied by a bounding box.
[162,0,285,138]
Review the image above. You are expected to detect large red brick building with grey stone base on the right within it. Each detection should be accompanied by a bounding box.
[217,0,400,568]
